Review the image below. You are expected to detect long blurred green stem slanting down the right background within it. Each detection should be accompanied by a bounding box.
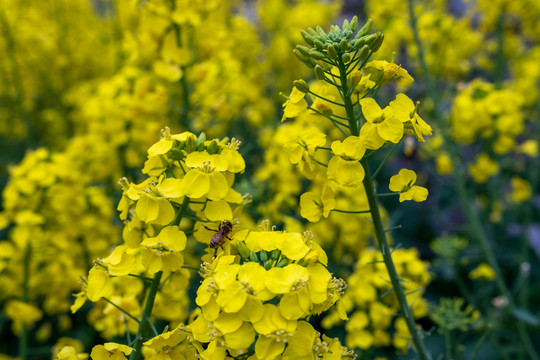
[408,0,538,360]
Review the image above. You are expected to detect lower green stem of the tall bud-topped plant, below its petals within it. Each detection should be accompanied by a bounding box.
[361,159,431,360]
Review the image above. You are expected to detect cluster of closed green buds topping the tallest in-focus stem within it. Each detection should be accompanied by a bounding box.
[293,16,384,74]
